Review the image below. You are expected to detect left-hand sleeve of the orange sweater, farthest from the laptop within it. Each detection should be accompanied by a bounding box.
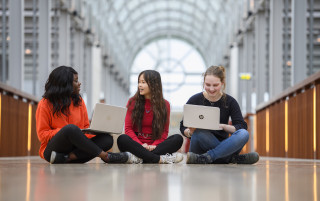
[36,100,61,144]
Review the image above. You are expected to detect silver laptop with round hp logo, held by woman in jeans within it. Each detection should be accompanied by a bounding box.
[183,104,222,130]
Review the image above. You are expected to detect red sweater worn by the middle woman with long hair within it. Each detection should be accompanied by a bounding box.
[125,98,170,146]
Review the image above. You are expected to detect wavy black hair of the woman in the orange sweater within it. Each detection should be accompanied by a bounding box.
[42,66,81,116]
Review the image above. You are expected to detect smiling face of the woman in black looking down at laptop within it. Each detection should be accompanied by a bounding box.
[203,75,223,100]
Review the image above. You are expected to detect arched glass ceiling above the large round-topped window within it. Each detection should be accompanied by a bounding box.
[83,0,243,71]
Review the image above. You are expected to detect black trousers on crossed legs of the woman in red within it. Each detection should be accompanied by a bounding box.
[117,134,183,163]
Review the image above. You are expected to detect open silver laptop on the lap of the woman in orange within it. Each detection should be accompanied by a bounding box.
[81,103,127,134]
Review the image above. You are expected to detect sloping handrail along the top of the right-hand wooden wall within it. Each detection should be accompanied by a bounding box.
[256,71,320,112]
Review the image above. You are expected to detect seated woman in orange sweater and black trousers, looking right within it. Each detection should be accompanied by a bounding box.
[36,66,128,163]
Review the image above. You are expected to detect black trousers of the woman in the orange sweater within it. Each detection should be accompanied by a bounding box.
[43,124,113,163]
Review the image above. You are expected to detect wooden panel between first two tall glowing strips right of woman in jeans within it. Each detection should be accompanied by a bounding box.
[269,101,286,157]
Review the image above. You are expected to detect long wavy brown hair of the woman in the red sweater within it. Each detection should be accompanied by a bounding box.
[128,70,168,140]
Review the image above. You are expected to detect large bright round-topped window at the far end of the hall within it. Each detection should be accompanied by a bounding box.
[130,39,206,111]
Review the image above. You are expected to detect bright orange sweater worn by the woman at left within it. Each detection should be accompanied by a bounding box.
[36,98,94,158]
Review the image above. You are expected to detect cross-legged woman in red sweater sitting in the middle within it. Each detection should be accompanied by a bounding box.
[117,70,183,163]
